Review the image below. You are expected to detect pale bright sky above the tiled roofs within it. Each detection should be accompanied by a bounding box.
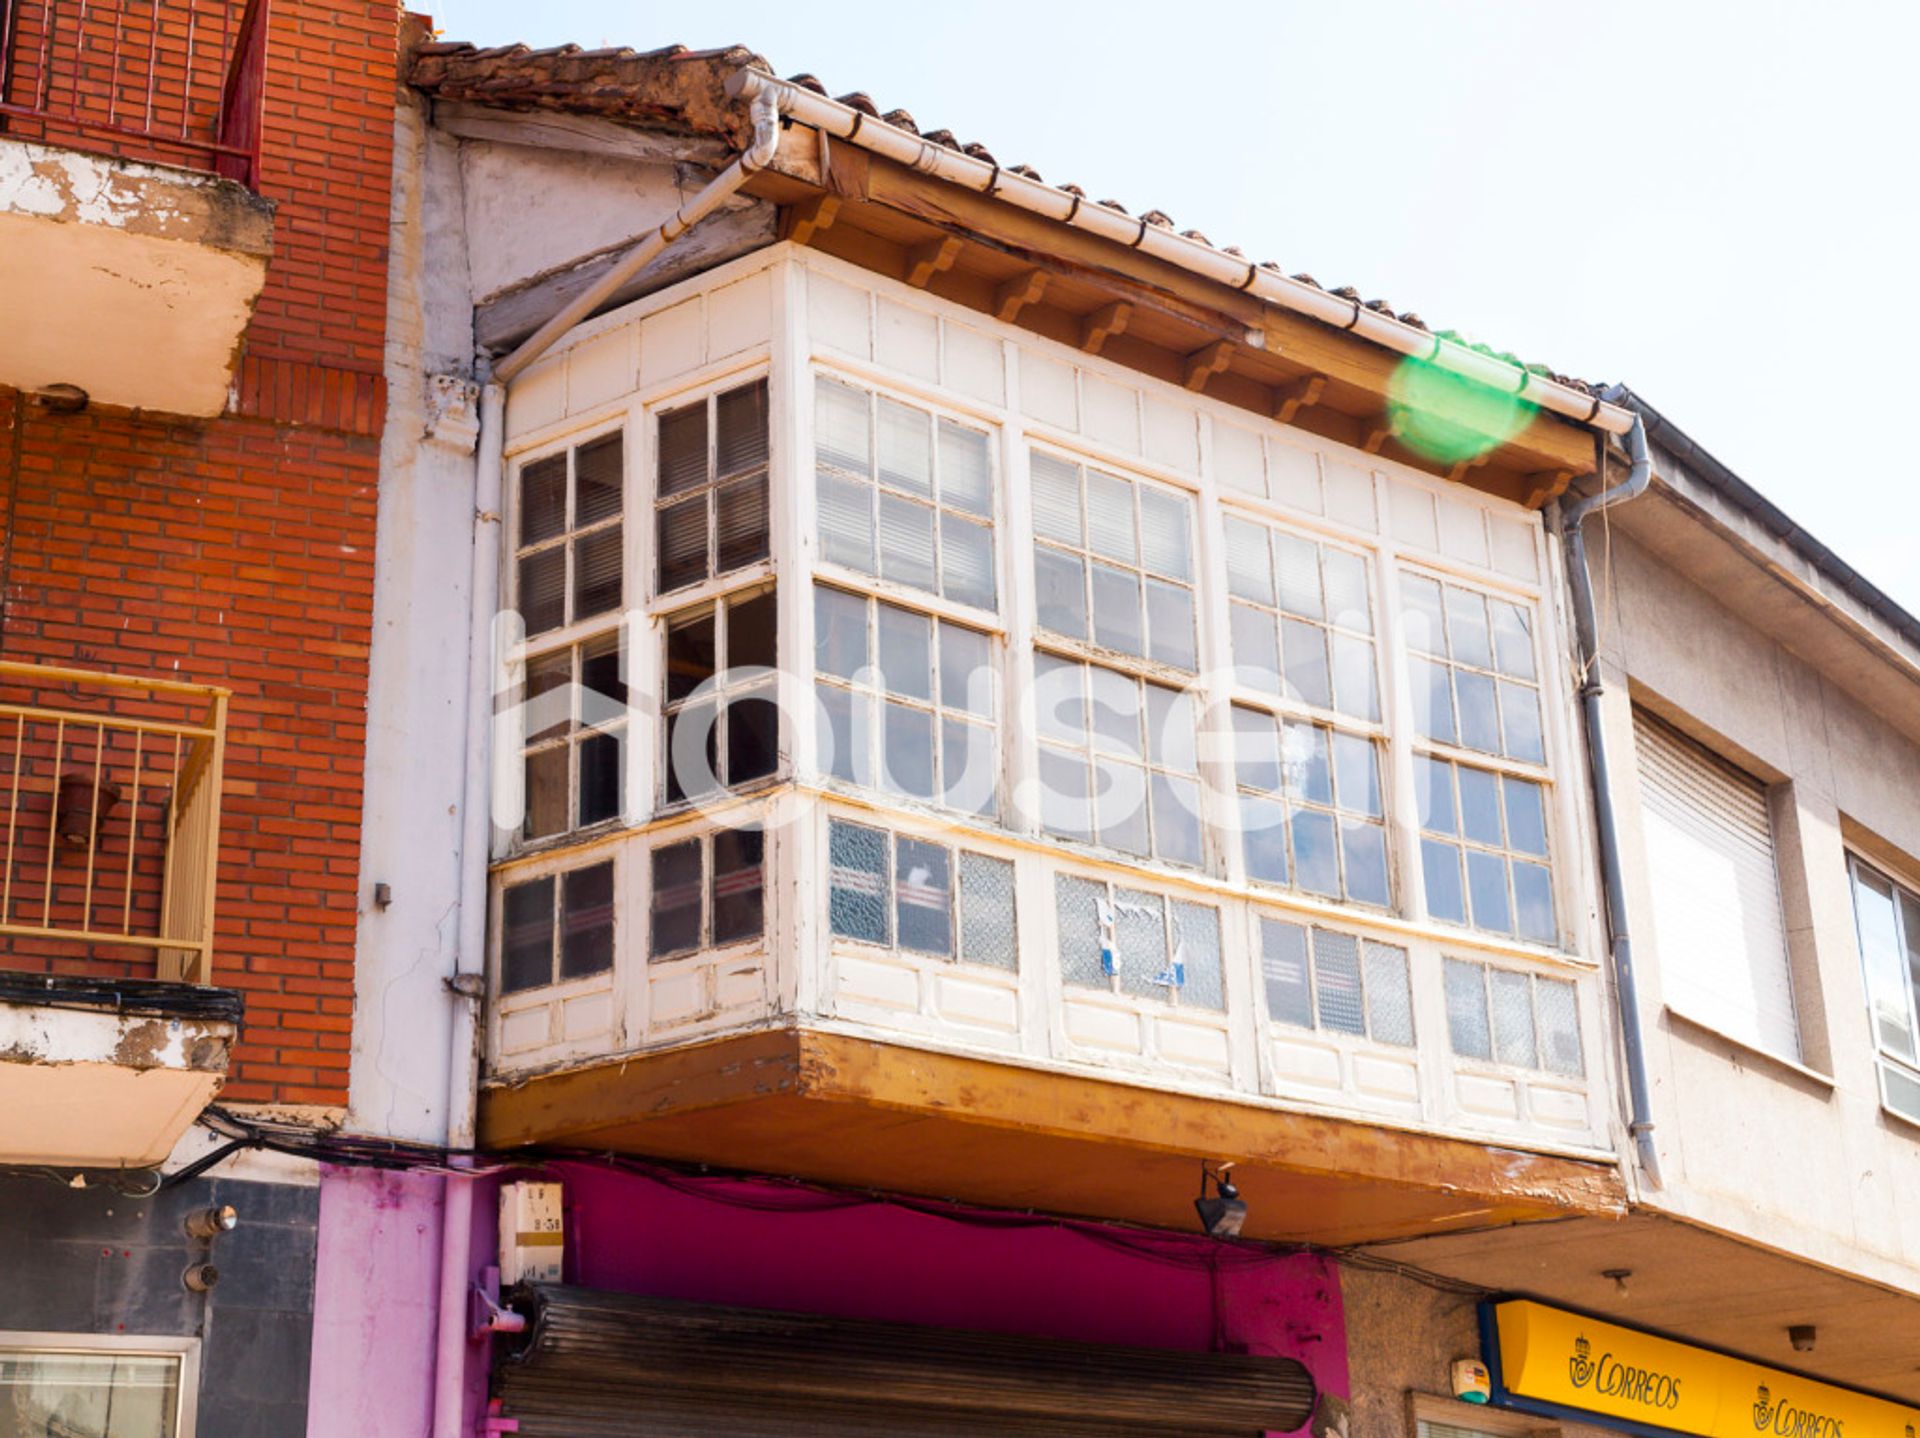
[430,0,1920,612]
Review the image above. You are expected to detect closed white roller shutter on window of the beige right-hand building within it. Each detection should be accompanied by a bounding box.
[1634,708,1799,1060]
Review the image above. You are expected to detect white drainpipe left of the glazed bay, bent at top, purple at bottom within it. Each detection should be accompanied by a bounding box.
[432,86,781,1438]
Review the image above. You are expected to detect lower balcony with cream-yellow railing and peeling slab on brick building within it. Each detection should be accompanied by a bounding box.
[0,662,240,1167]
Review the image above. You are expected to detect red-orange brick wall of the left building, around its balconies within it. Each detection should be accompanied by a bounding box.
[0,0,399,1104]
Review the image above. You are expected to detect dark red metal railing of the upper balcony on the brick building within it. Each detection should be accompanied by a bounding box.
[0,0,267,188]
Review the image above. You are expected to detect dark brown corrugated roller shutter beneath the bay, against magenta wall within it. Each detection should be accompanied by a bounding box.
[493,1284,1315,1438]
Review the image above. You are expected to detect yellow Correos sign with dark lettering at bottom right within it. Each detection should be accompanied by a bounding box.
[1490,1300,1920,1438]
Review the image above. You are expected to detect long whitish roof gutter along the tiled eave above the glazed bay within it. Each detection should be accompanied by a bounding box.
[728,69,1634,434]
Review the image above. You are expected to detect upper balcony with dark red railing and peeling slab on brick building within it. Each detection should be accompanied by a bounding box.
[0,0,273,415]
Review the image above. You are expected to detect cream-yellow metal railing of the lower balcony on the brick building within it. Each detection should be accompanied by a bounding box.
[0,662,228,983]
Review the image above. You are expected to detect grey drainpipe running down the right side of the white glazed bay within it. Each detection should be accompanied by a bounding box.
[1561,386,1661,1188]
